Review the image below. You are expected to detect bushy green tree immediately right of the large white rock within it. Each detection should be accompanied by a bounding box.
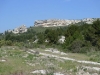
[65,25,83,46]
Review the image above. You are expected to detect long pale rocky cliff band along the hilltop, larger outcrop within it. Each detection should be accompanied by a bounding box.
[34,18,97,27]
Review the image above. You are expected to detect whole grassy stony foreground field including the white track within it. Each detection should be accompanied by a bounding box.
[0,46,100,75]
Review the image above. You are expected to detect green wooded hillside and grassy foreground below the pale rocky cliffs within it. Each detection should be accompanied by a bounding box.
[0,19,100,75]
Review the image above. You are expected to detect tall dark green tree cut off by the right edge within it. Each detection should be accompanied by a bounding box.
[84,19,100,48]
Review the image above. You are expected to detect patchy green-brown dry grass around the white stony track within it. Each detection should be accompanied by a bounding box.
[0,49,98,75]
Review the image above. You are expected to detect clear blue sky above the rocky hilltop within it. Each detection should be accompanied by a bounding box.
[0,0,100,32]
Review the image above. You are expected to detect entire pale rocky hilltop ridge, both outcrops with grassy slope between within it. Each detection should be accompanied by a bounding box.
[7,18,100,34]
